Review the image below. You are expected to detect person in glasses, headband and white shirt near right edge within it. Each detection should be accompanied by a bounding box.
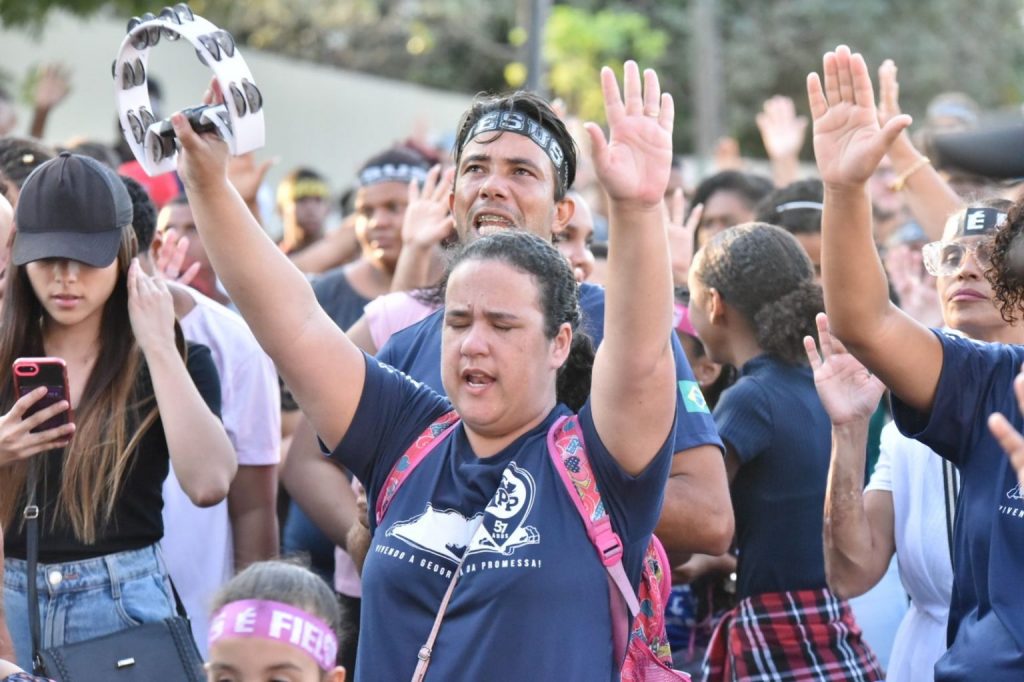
[819,200,1024,682]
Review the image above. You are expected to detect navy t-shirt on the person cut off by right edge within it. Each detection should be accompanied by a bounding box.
[893,330,1024,682]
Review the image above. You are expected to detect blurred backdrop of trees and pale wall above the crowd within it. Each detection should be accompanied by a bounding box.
[0,0,1024,191]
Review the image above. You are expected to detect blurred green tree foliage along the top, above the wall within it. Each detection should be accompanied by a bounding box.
[0,0,1024,155]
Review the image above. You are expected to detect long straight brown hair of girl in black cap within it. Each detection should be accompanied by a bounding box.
[0,225,158,544]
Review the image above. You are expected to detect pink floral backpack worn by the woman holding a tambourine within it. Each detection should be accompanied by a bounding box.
[375,411,690,682]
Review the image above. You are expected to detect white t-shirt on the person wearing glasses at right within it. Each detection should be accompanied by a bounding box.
[865,423,953,682]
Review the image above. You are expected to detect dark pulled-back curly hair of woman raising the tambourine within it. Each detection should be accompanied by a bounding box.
[442,229,594,412]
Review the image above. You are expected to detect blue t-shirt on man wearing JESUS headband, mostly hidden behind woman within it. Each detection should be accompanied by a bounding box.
[377,283,722,453]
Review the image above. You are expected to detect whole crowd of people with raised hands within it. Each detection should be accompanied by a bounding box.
[0,35,1024,682]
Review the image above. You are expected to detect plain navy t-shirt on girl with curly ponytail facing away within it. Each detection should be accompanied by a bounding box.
[715,354,831,598]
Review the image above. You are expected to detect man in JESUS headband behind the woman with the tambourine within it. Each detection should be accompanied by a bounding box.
[378,92,733,554]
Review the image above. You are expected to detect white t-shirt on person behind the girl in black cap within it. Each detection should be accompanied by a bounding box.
[161,289,281,657]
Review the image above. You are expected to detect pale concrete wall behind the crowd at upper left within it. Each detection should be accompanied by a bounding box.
[0,5,470,190]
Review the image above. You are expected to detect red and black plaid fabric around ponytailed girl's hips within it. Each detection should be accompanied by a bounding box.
[702,590,885,682]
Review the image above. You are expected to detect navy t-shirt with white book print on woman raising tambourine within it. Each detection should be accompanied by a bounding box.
[331,357,673,682]
